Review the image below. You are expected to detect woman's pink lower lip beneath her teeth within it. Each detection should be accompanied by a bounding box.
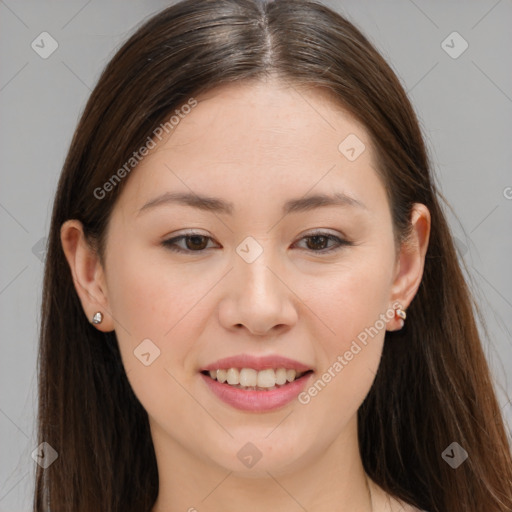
[200,372,313,412]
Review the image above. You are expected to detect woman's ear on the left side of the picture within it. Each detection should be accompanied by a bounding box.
[60,219,114,332]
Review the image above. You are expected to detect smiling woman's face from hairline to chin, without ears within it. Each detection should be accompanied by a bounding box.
[97,82,397,475]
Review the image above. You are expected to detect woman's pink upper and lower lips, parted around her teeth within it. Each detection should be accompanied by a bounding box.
[200,354,312,412]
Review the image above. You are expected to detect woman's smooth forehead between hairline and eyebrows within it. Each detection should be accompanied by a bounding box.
[113,80,383,216]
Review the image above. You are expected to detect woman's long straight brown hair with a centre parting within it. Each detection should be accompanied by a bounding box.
[34,0,512,512]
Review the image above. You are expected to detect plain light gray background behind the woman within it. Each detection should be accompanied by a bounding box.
[0,0,512,512]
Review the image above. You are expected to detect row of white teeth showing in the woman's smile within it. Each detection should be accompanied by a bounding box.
[205,368,305,390]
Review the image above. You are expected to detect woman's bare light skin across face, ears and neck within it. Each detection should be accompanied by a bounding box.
[61,80,430,512]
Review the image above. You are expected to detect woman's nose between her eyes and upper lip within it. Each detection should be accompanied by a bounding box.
[219,250,298,336]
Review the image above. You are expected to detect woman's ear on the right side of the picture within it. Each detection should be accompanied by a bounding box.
[389,203,430,330]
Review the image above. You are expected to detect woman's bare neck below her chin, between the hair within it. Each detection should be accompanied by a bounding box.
[152,421,373,512]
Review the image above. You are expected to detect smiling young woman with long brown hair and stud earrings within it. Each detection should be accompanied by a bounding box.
[35,0,512,512]
